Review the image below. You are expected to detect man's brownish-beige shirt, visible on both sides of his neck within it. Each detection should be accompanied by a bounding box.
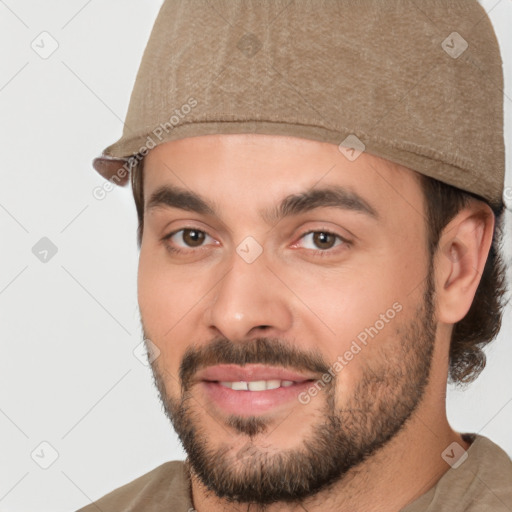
[78,435,512,512]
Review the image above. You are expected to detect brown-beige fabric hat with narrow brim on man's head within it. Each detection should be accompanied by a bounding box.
[94,0,505,207]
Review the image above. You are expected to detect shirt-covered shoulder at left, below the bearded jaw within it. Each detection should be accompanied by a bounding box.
[78,461,192,512]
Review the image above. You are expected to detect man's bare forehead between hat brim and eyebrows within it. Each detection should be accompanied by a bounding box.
[144,134,423,218]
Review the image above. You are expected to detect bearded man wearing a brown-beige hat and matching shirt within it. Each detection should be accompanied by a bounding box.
[78,0,512,512]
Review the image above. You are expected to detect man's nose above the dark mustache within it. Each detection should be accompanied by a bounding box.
[206,254,292,340]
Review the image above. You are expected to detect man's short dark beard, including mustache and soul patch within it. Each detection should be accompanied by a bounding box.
[143,272,436,509]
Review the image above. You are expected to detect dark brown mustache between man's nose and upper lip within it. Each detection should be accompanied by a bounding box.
[179,338,329,390]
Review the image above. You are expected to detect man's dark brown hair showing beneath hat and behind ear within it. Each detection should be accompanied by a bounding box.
[131,160,506,385]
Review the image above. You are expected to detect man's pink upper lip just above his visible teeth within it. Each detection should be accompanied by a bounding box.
[196,364,315,382]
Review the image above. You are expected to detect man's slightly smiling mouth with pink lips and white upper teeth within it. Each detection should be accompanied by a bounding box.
[196,364,316,416]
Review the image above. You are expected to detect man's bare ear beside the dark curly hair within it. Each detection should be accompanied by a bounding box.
[436,199,495,324]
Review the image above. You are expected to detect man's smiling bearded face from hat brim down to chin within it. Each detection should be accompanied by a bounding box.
[138,135,435,503]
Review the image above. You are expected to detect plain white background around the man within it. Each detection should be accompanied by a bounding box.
[0,0,512,512]
